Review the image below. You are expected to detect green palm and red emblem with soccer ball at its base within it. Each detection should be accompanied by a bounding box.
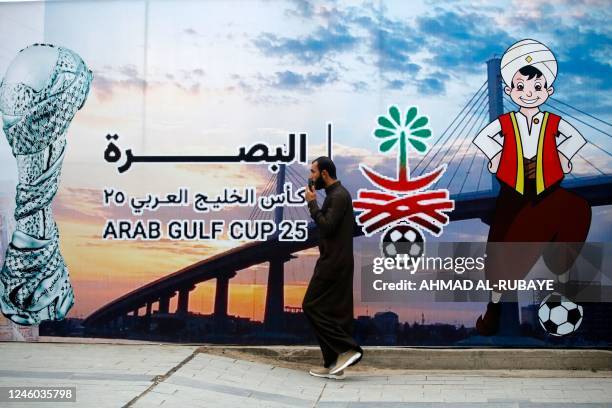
[353,106,455,257]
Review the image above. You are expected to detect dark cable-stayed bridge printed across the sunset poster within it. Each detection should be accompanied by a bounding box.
[84,58,612,334]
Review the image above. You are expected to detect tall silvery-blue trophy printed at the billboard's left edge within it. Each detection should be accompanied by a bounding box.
[0,44,93,326]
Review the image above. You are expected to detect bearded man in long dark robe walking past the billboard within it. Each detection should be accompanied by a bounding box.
[302,156,363,379]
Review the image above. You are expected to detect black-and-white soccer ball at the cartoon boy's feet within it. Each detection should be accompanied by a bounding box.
[538,292,582,336]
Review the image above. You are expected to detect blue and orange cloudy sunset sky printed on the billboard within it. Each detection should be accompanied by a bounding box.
[0,0,612,325]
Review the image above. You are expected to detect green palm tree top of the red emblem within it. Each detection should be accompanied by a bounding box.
[374,105,431,180]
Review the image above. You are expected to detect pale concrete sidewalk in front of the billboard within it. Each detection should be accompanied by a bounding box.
[0,343,612,408]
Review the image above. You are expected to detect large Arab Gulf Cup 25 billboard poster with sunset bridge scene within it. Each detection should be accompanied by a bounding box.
[0,0,612,347]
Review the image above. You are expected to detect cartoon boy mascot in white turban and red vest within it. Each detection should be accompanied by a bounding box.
[473,39,591,336]
